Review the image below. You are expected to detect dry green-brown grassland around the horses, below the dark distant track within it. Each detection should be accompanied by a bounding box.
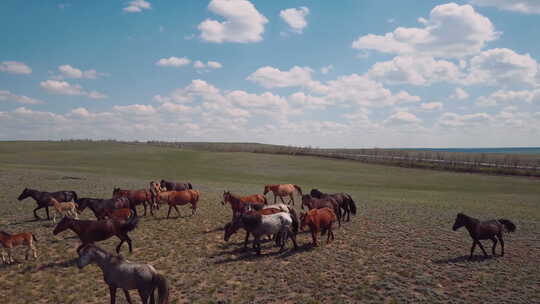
[0,142,540,303]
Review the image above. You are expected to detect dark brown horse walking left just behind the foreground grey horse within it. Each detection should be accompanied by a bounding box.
[53,216,139,253]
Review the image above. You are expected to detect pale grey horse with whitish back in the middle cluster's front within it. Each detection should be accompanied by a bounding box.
[223,212,298,255]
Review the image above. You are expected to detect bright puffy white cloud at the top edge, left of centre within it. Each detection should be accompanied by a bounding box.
[198,0,268,43]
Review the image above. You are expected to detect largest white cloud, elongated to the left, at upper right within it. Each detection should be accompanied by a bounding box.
[352,3,500,58]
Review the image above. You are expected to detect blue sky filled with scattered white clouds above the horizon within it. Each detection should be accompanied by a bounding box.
[0,0,540,148]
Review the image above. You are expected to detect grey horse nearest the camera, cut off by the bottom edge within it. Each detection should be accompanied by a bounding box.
[77,245,169,304]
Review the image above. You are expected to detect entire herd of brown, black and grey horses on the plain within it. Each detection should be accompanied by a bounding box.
[0,180,516,303]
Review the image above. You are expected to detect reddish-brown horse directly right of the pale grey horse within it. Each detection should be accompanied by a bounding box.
[300,207,337,247]
